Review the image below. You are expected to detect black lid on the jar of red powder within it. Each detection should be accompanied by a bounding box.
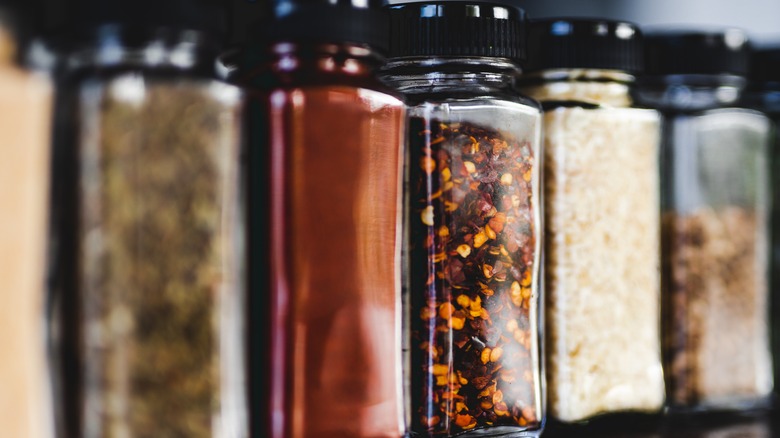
[250,0,388,52]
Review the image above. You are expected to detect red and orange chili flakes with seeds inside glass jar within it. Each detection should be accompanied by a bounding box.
[409,118,540,435]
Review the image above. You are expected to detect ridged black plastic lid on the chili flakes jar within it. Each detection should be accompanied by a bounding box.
[389,1,526,61]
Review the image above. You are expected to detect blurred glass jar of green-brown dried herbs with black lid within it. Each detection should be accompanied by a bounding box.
[54,0,248,437]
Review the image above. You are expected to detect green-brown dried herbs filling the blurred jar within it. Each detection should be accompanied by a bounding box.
[80,77,240,437]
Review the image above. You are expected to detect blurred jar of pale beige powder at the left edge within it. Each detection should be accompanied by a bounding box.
[0,1,53,438]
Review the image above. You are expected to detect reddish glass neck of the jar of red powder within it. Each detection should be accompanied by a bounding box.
[238,42,384,87]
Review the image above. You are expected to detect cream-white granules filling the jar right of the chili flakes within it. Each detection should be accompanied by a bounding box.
[544,103,664,422]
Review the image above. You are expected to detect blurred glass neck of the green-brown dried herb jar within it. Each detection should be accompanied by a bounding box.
[66,26,219,76]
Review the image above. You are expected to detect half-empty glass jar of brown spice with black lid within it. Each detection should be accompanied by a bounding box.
[639,29,772,409]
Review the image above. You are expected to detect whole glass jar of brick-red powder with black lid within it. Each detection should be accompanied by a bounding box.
[241,0,404,438]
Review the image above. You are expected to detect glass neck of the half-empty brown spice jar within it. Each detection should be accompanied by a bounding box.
[637,75,747,111]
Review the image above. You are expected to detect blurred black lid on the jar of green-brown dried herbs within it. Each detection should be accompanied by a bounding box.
[69,0,227,38]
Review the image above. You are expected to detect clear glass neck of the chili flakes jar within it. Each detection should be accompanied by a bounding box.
[382,57,520,95]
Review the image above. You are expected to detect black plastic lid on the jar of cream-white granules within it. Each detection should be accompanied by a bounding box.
[526,18,644,73]
